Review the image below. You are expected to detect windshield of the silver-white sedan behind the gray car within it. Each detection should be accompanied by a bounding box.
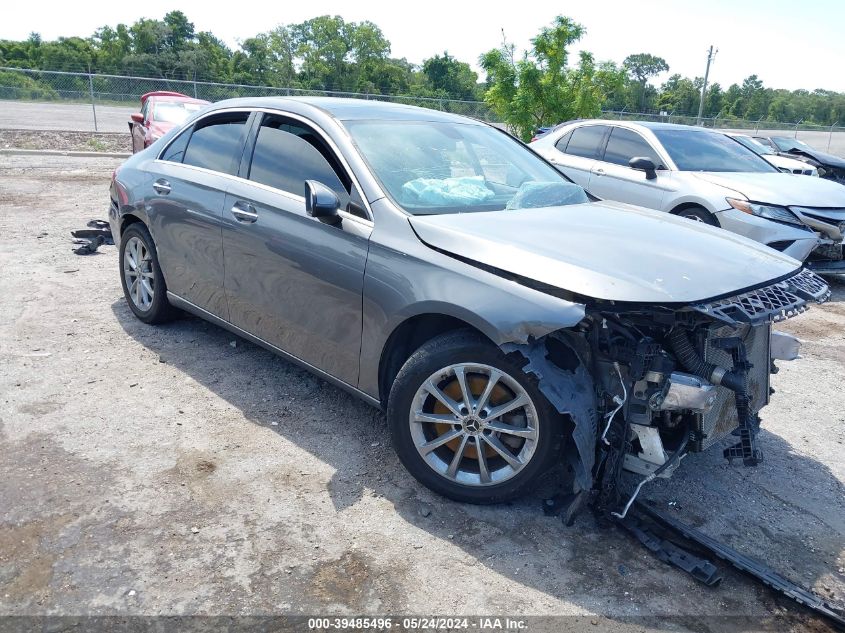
[654,129,777,172]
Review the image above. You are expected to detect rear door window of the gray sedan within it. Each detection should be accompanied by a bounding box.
[182,112,249,175]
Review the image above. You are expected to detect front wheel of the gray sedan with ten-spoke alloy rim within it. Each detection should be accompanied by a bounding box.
[387,330,564,504]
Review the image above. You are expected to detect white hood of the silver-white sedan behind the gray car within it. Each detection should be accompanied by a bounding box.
[695,171,845,207]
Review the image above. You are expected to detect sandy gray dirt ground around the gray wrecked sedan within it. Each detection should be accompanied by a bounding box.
[0,156,845,630]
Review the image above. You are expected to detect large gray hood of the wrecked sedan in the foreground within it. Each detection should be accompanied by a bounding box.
[410,200,800,303]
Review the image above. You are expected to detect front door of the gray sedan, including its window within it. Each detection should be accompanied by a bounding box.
[223,114,372,385]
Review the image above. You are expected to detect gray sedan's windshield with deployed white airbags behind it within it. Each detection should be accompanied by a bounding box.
[345,121,589,215]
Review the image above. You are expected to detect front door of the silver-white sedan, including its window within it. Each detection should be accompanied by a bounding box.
[590,126,671,209]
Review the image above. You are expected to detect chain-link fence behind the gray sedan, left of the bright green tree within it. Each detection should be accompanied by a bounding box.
[0,67,495,131]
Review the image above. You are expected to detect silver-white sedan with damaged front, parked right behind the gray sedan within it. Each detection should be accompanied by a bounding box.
[530,120,845,273]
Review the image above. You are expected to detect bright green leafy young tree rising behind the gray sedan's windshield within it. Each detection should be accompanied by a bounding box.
[480,16,624,140]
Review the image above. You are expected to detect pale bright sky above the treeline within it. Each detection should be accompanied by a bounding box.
[0,0,845,92]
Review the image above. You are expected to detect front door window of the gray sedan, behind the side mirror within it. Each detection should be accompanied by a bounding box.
[249,117,350,202]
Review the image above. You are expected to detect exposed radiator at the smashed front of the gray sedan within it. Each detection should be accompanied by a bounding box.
[690,323,771,451]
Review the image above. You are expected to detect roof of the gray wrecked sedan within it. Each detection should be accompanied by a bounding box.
[199,97,483,125]
